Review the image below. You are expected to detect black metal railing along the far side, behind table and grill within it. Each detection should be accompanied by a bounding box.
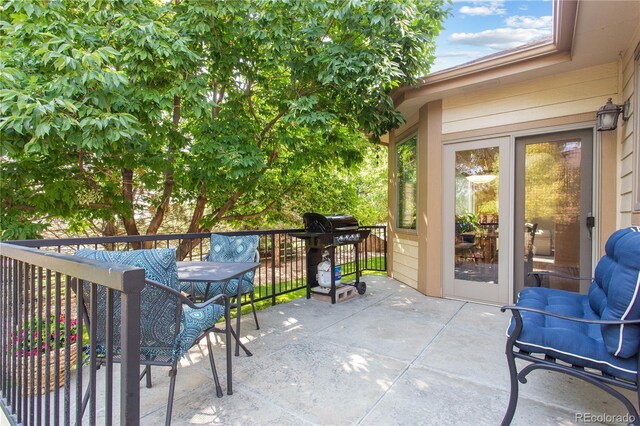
[12,226,387,305]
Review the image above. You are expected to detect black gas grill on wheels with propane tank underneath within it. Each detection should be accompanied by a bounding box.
[291,213,371,303]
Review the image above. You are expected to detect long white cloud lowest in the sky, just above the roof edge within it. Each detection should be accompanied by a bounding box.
[449,28,549,50]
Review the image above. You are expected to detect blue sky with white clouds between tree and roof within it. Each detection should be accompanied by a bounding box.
[431,0,553,73]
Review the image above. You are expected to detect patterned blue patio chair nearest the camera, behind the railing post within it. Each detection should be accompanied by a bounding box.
[75,249,233,425]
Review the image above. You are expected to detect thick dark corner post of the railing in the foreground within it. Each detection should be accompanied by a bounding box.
[120,269,144,425]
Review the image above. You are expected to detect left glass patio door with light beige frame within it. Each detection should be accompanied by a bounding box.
[443,138,510,303]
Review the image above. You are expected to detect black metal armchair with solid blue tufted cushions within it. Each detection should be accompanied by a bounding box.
[501,227,640,425]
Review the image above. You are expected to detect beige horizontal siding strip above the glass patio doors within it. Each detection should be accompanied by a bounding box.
[442,62,619,134]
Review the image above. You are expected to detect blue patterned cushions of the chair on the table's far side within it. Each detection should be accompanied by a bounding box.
[180,234,260,297]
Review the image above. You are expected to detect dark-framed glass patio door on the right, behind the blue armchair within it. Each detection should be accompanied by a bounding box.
[514,130,593,292]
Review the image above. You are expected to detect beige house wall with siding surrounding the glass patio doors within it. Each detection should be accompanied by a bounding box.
[389,61,628,296]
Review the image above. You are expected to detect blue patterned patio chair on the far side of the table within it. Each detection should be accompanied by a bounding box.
[180,234,260,356]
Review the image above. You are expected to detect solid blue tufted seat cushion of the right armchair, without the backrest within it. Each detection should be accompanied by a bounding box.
[507,288,638,380]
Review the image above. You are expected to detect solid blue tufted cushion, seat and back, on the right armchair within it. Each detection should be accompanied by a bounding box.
[507,228,640,380]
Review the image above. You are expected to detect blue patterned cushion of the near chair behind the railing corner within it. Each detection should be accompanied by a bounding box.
[76,249,224,362]
